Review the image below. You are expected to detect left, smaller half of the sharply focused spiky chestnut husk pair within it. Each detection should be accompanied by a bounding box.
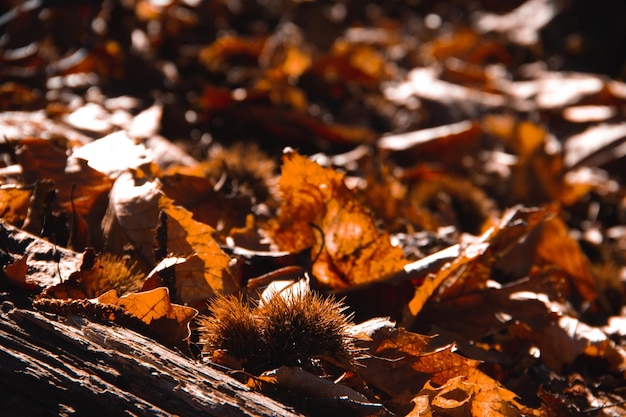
[198,295,266,369]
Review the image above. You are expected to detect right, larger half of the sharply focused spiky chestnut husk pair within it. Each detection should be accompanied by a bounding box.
[255,292,357,369]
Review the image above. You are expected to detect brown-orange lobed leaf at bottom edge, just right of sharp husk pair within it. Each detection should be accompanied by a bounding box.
[359,328,542,417]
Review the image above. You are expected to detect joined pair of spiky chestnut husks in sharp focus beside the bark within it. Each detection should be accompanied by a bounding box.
[198,292,359,373]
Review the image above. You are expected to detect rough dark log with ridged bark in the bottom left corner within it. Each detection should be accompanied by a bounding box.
[0,301,297,416]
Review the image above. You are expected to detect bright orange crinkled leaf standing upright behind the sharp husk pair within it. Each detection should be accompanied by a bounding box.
[271,152,407,288]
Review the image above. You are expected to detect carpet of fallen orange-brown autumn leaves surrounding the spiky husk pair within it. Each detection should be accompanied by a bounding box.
[0,0,626,416]
